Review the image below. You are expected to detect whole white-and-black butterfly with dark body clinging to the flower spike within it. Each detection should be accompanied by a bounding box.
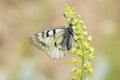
[28,23,74,59]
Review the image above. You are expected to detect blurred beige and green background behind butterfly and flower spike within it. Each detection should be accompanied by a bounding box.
[0,0,120,80]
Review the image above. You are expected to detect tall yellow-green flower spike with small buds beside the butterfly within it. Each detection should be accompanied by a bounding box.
[64,4,94,80]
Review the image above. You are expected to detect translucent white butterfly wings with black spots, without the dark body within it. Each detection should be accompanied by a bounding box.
[29,28,66,59]
